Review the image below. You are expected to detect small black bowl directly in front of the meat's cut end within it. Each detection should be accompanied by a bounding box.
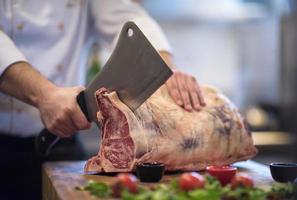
[136,163,165,182]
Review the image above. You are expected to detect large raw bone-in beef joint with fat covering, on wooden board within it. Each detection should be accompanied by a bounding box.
[85,86,257,172]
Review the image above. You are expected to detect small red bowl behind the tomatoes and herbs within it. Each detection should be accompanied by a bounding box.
[206,166,237,186]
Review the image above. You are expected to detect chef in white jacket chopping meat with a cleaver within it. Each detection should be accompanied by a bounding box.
[0,0,205,199]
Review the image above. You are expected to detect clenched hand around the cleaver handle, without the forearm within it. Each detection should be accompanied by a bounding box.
[37,87,90,137]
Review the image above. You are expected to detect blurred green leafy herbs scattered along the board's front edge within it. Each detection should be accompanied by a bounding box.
[77,176,293,200]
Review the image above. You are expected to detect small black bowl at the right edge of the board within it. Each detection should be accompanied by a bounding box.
[270,163,297,183]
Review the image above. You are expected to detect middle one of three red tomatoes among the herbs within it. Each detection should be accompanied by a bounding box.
[178,172,205,191]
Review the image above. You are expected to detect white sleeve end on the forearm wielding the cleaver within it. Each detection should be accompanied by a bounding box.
[0,30,27,76]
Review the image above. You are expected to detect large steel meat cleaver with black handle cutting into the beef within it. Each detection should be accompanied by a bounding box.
[35,22,172,156]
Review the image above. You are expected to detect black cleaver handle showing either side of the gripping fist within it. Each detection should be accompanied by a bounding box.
[35,91,90,156]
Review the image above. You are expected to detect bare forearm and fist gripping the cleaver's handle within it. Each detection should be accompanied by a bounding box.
[0,62,90,137]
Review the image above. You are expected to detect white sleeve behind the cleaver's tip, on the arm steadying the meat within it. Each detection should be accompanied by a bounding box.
[90,0,171,52]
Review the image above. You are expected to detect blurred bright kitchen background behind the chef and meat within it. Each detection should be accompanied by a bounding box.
[80,0,297,164]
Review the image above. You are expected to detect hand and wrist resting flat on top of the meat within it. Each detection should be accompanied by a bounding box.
[160,52,206,111]
